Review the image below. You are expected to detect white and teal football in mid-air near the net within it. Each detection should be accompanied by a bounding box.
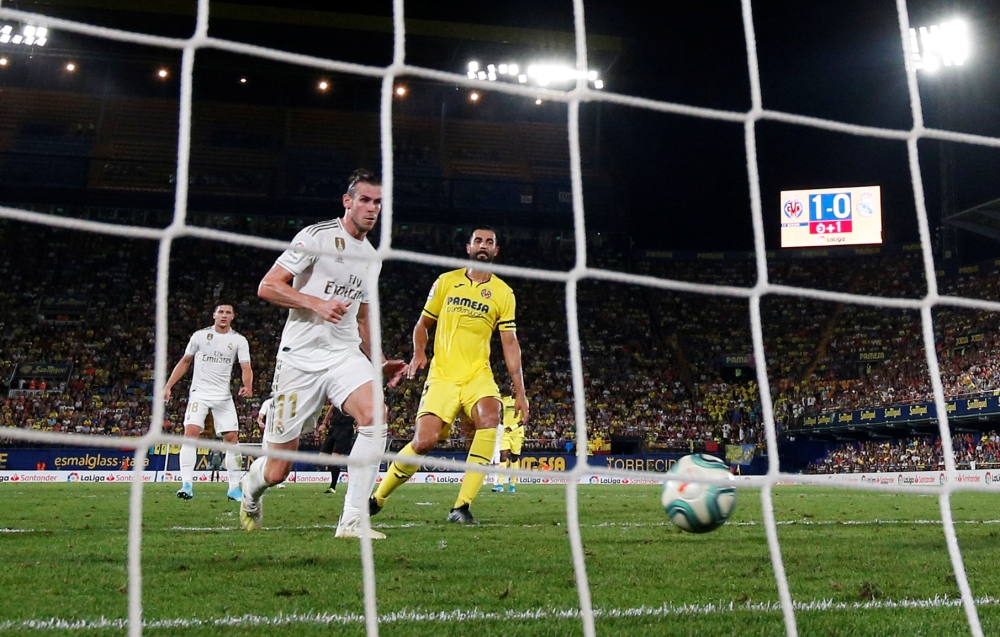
[661,453,736,533]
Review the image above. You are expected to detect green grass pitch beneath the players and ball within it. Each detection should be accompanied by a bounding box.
[0,483,1000,637]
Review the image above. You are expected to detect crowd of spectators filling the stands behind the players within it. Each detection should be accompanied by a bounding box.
[0,222,1000,464]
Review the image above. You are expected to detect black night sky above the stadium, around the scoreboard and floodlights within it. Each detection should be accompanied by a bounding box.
[4,0,1000,250]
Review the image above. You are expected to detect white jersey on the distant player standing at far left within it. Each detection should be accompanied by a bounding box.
[184,326,250,400]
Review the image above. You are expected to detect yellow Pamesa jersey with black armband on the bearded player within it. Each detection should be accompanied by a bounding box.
[424,268,516,381]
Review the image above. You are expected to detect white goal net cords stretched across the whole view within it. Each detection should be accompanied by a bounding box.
[0,0,1000,637]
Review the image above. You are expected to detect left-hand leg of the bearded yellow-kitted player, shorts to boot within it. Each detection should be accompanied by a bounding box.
[369,378,460,515]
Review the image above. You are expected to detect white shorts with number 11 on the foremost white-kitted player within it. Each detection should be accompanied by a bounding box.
[264,349,375,444]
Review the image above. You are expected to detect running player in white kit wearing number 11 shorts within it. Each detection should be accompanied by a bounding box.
[240,170,406,539]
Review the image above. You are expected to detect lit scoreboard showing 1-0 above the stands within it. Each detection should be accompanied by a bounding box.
[781,186,882,248]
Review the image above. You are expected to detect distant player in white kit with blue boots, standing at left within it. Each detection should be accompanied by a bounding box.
[163,304,253,500]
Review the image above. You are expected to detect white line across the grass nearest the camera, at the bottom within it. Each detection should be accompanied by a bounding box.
[0,595,1000,630]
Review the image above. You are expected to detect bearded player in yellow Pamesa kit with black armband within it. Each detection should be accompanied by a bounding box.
[369,227,528,524]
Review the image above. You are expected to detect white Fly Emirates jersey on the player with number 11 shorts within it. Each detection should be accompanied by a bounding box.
[275,219,382,372]
